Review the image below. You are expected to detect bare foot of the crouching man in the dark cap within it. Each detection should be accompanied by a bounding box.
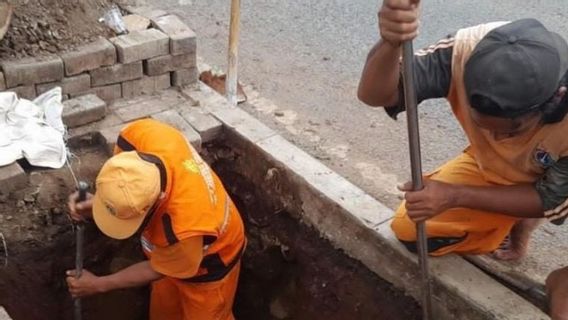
[493,219,541,261]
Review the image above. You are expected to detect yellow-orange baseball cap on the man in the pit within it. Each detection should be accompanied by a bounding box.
[93,151,161,239]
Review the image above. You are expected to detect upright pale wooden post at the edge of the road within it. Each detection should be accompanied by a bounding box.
[225,0,241,107]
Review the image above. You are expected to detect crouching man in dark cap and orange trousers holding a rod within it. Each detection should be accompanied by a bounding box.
[358,0,568,320]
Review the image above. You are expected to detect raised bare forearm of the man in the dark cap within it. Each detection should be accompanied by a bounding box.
[357,40,402,106]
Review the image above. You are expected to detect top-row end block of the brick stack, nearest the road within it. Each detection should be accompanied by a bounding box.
[152,15,197,56]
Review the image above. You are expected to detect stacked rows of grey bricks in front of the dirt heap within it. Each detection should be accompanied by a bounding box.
[0,12,197,101]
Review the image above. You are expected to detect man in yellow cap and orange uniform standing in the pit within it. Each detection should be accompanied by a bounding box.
[67,119,246,320]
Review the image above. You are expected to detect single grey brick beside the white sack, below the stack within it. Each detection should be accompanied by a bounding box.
[63,94,106,128]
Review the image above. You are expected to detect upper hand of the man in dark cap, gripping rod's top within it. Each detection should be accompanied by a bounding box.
[379,0,420,46]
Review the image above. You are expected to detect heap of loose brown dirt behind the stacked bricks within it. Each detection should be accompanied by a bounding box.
[0,0,116,60]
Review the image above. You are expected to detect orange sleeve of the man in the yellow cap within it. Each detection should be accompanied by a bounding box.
[150,236,203,279]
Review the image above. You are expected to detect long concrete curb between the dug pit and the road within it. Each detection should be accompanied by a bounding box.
[183,84,549,320]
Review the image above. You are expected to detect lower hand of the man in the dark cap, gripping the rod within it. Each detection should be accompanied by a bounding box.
[399,178,456,222]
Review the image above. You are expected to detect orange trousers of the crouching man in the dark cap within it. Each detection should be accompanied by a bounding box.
[391,153,520,256]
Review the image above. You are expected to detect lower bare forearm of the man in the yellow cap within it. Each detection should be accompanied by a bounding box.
[100,261,162,292]
